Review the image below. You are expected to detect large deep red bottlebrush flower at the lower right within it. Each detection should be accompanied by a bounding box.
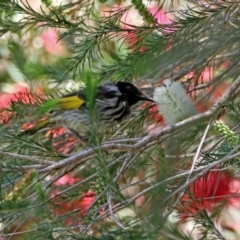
[177,171,240,218]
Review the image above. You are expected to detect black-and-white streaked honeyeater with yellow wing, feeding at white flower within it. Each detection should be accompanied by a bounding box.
[21,82,153,135]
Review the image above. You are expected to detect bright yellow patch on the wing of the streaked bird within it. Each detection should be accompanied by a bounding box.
[57,96,85,110]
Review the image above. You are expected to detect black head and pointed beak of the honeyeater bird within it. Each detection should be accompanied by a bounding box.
[116,82,154,106]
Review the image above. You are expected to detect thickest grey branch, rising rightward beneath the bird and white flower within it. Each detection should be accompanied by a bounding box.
[38,76,240,173]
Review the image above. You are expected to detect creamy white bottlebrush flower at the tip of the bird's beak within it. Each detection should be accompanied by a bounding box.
[153,79,197,125]
